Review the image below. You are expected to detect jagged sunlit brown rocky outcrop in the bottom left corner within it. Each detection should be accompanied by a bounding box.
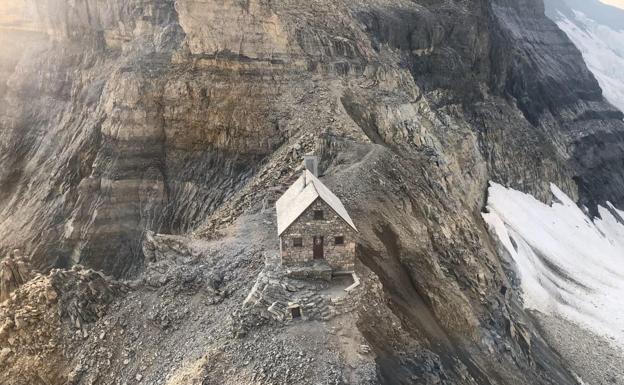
[0,268,125,385]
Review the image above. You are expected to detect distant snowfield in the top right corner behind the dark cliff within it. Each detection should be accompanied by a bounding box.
[556,11,624,111]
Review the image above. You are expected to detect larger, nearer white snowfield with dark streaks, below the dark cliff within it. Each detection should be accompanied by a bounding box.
[483,183,624,347]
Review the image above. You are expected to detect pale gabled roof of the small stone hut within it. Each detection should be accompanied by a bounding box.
[275,170,357,235]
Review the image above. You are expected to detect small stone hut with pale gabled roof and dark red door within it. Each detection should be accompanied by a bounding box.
[276,168,357,275]
